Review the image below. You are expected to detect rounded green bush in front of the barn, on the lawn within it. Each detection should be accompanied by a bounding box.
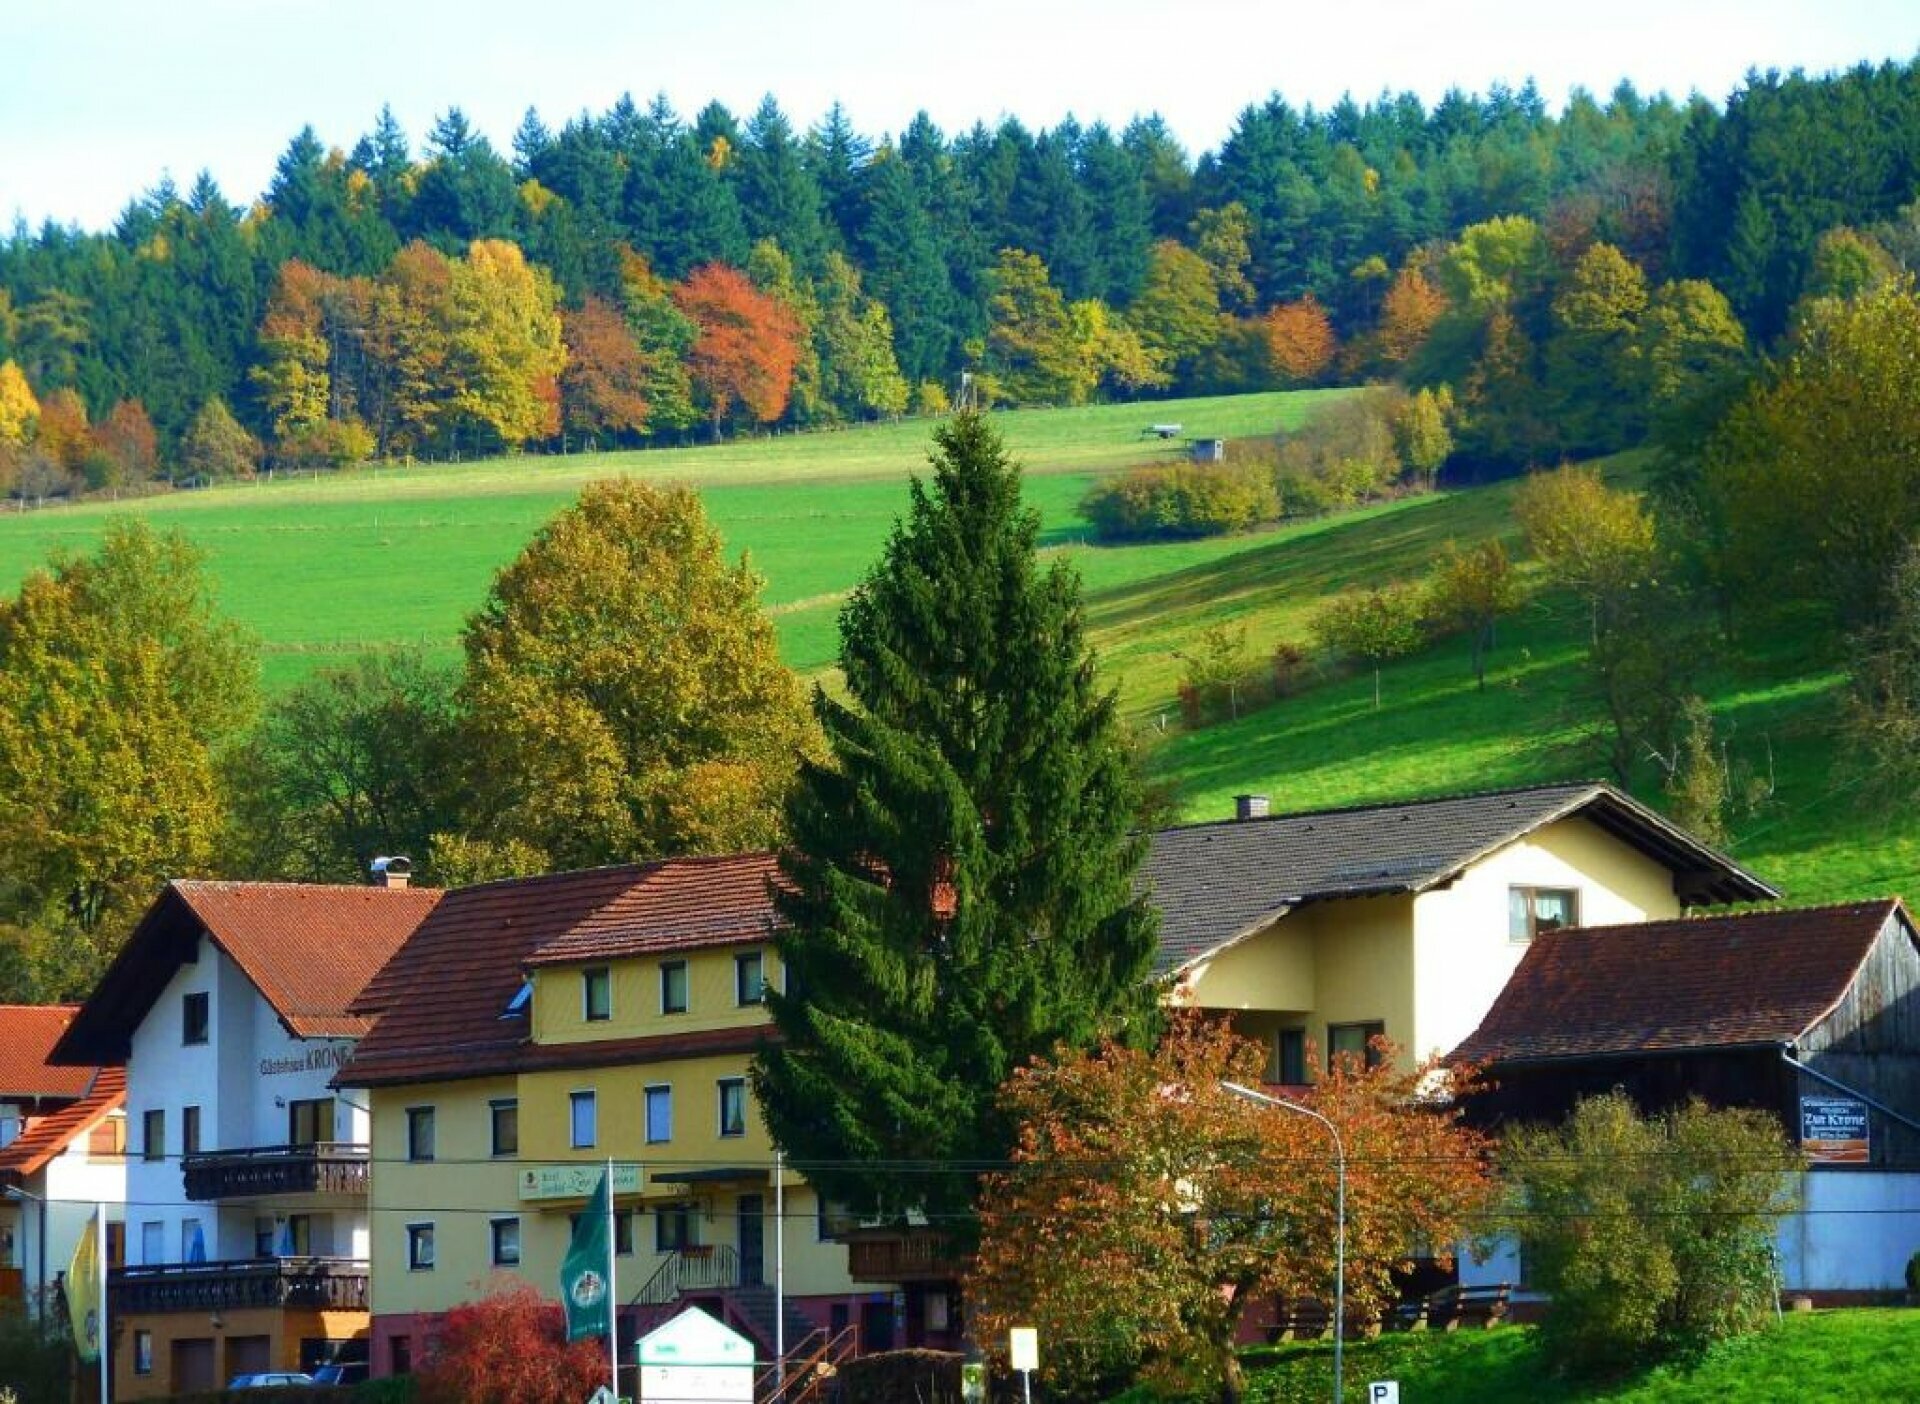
[1500,1093,1797,1375]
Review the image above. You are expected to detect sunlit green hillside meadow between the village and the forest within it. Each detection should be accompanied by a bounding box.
[0,392,1920,901]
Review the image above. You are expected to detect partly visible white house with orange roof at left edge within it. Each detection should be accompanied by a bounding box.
[0,1005,127,1310]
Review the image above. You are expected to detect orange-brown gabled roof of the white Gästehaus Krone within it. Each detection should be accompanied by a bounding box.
[54,882,440,1064]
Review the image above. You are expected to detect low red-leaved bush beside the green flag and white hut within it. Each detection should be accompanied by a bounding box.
[420,1279,607,1404]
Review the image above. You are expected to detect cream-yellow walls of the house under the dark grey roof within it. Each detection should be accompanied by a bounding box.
[1177,818,1680,1076]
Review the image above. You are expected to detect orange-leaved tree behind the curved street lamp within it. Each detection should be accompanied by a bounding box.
[968,1014,1492,1400]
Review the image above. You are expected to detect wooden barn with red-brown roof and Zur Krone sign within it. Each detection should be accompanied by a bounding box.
[1452,899,1920,1298]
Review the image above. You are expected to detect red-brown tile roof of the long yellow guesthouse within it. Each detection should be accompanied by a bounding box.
[349,853,774,1087]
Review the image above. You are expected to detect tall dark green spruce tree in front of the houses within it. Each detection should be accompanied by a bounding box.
[755,415,1156,1237]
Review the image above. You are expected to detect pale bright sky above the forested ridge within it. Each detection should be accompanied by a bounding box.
[0,0,1920,229]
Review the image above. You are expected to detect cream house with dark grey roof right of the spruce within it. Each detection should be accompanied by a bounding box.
[1144,784,1780,1083]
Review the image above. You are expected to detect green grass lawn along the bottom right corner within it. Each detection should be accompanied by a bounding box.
[1228,1310,1920,1404]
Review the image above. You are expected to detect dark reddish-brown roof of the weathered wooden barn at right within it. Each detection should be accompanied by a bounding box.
[1452,897,1912,1064]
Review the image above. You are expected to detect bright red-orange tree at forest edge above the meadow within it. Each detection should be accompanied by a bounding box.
[674,263,801,438]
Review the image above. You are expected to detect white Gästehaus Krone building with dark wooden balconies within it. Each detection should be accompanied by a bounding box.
[50,864,440,1400]
